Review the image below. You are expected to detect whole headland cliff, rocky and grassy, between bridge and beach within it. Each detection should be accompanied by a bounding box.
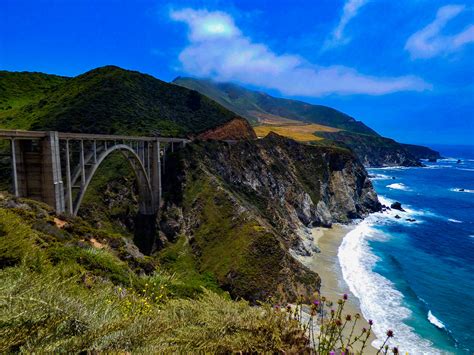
[161,134,380,301]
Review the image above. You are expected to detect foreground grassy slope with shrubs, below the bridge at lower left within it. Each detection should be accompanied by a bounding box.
[0,195,306,353]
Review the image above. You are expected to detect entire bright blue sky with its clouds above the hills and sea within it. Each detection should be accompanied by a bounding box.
[0,0,474,144]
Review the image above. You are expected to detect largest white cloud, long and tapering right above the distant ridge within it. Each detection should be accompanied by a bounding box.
[170,9,430,96]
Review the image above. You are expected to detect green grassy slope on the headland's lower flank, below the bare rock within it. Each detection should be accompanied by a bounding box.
[179,172,285,301]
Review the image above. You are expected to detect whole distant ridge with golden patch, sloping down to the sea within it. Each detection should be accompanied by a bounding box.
[173,77,439,166]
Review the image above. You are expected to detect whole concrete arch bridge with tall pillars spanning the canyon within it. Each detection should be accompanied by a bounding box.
[0,130,189,216]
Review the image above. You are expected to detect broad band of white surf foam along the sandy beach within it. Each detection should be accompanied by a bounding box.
[338,213,439,354]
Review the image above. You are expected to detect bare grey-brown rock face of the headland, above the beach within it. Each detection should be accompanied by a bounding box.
[198,134,378,226]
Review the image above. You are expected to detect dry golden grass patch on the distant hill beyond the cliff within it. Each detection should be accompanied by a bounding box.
[254,124,340,142]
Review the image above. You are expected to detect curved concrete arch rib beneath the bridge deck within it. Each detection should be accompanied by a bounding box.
[73,144,156,216]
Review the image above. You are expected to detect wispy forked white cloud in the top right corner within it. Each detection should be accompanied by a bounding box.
[405,5,474,59]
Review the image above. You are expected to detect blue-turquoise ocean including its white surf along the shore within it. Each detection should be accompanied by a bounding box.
[338,146,474,354]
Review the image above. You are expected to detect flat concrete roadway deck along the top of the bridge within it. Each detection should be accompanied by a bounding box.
[0,129,190,143]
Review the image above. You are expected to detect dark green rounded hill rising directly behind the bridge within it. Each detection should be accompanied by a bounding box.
[0,66,254,137]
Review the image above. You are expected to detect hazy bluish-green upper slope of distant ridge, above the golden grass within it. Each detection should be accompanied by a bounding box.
[173,77,377,135]
